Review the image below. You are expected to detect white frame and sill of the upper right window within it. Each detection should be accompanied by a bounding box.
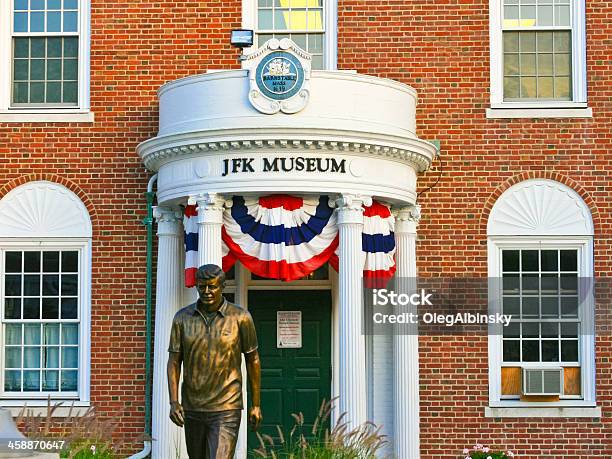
[487,0,593,118]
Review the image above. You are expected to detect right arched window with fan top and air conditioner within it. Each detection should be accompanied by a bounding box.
[487,179,595,412]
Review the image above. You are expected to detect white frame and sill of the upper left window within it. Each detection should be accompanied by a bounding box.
[0,0,94,122]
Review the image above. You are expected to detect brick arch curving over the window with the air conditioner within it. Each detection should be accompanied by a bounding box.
[480,171,600,234]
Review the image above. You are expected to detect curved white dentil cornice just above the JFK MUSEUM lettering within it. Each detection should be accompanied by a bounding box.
[137,131,437,172]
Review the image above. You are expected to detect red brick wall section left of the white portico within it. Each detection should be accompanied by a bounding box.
[0,0,241,451]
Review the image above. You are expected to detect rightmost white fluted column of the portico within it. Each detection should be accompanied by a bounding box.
[393,206,420,459]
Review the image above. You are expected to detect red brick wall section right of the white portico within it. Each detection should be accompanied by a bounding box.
[338,0,612,459]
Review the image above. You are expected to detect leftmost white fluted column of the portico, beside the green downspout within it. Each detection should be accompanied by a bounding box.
[151,207,183,459]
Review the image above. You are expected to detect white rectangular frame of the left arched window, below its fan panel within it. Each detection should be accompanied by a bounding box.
[0,238,91,416]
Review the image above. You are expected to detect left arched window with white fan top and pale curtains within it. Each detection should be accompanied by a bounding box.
[0,181,92,406]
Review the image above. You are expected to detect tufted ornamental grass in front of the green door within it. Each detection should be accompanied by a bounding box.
[253,401,386,459]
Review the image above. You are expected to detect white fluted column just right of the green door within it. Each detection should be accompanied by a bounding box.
[335,195,372,428]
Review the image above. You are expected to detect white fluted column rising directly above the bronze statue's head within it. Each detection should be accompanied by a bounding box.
[189,193,225,266]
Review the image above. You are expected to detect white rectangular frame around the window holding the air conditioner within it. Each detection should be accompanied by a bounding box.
[488,236,595,410]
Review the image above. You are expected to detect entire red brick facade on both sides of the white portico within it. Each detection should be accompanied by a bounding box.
[0,0,612,459]
